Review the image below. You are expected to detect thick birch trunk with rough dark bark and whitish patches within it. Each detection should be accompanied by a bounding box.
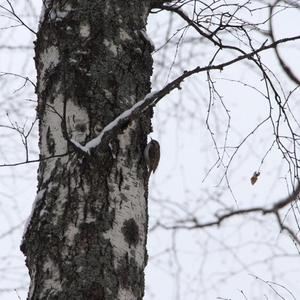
[21,0,152,300]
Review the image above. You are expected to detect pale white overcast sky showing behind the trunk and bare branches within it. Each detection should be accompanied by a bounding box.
[0,1,300,300]
